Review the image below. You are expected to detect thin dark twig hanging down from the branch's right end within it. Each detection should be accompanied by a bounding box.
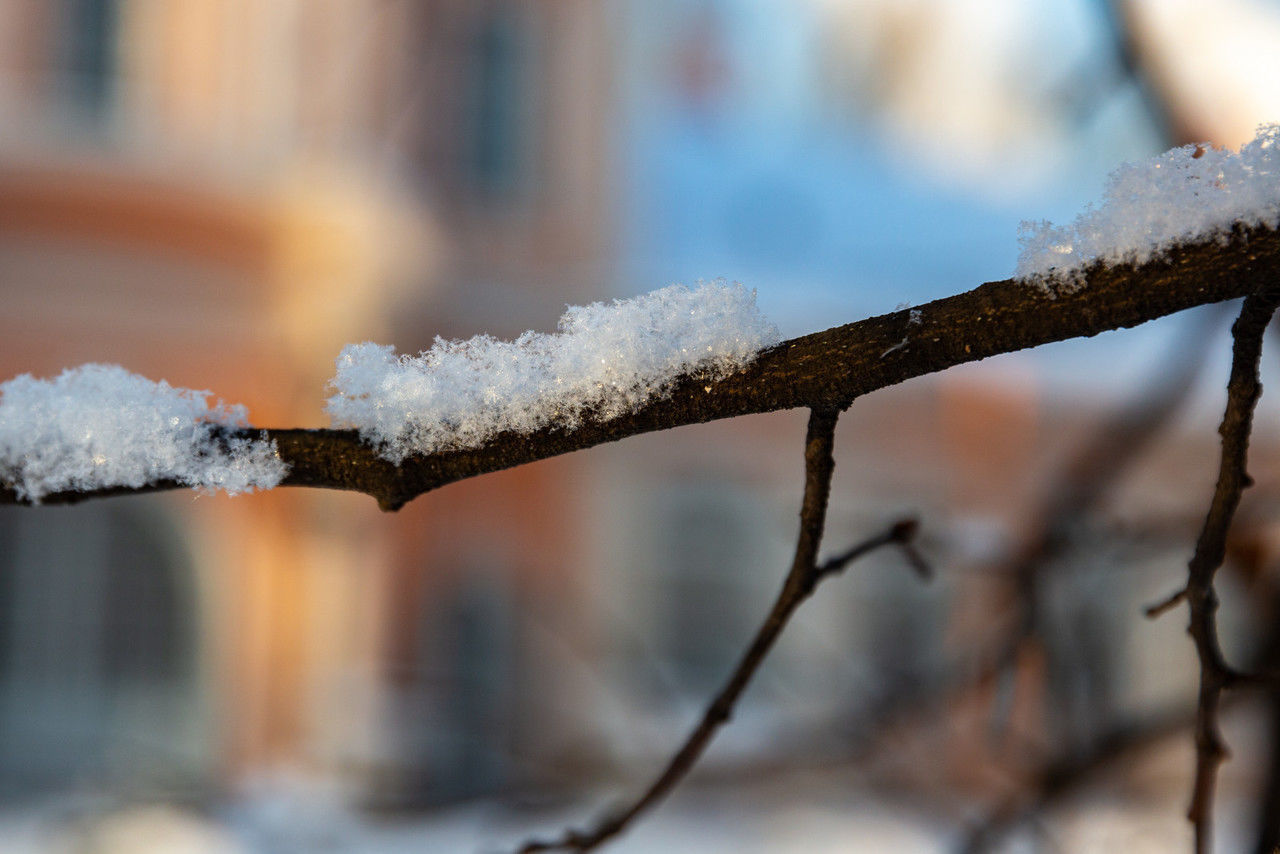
[1184,287,1280,854]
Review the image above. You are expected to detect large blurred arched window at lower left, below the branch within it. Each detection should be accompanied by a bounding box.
[0,502,196,796]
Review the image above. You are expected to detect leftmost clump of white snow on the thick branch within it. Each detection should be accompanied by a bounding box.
[0,365,288,502]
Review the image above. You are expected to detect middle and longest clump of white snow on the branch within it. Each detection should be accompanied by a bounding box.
[328,282,780,463]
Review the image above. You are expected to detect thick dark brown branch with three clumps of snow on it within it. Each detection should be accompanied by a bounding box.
[0,229,1280,510]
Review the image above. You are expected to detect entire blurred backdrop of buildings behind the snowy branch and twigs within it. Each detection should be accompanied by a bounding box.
[0,0,1280,853]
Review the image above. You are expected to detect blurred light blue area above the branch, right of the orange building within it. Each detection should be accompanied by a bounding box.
[620,0,1161,332]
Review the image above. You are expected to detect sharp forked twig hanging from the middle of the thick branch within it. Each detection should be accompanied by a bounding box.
[520,410,919,854]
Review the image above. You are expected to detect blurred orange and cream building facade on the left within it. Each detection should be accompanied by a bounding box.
[0,0,609,802]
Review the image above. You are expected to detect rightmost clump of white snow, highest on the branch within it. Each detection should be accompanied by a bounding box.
[1014,124,1280,291]
